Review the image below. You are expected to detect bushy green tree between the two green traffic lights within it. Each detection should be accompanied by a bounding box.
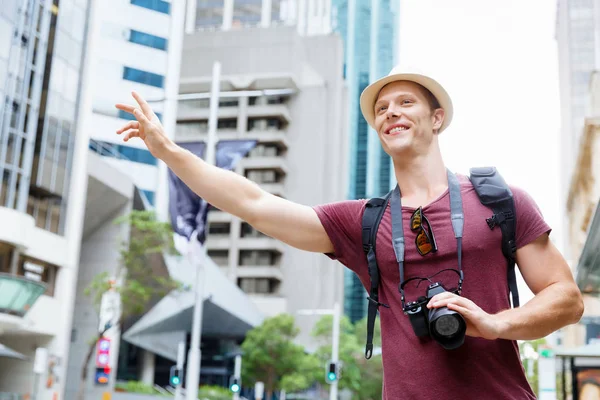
[241,314,318,400]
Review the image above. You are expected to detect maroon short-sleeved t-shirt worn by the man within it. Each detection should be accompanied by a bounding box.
[315,176,550,400]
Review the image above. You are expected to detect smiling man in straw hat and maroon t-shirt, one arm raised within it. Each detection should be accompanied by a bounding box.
[117,69,583,400]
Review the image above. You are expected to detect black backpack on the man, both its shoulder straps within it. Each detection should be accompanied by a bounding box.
[362,167,519,359]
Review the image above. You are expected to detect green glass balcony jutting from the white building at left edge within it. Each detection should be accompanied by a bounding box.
[0,273,46,330]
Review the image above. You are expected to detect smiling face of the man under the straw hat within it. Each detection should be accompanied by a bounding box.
[374,81,444,157]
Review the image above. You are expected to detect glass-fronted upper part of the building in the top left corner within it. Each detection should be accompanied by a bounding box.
[0,0,88,235]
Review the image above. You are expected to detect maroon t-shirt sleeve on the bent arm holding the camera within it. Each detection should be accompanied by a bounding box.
[511,187,552,249]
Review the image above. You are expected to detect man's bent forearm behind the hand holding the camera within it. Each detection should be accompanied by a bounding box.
[495,282,583,340]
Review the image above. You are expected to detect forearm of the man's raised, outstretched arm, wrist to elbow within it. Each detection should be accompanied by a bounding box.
[160,142,266,221]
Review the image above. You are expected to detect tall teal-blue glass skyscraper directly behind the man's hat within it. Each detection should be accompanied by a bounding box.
[332,0,399,322]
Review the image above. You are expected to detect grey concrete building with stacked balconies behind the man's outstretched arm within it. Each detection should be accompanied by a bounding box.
[175,27,348,347]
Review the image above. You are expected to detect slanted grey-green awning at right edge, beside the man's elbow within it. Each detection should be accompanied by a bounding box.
[576,202,600,295]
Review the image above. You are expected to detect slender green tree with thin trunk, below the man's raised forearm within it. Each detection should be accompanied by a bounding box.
[78,211,180,400]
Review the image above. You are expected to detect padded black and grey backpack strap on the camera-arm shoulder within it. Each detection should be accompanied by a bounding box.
[469,167,519,307]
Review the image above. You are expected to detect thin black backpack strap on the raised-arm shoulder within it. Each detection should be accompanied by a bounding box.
[362,191,392,359]
